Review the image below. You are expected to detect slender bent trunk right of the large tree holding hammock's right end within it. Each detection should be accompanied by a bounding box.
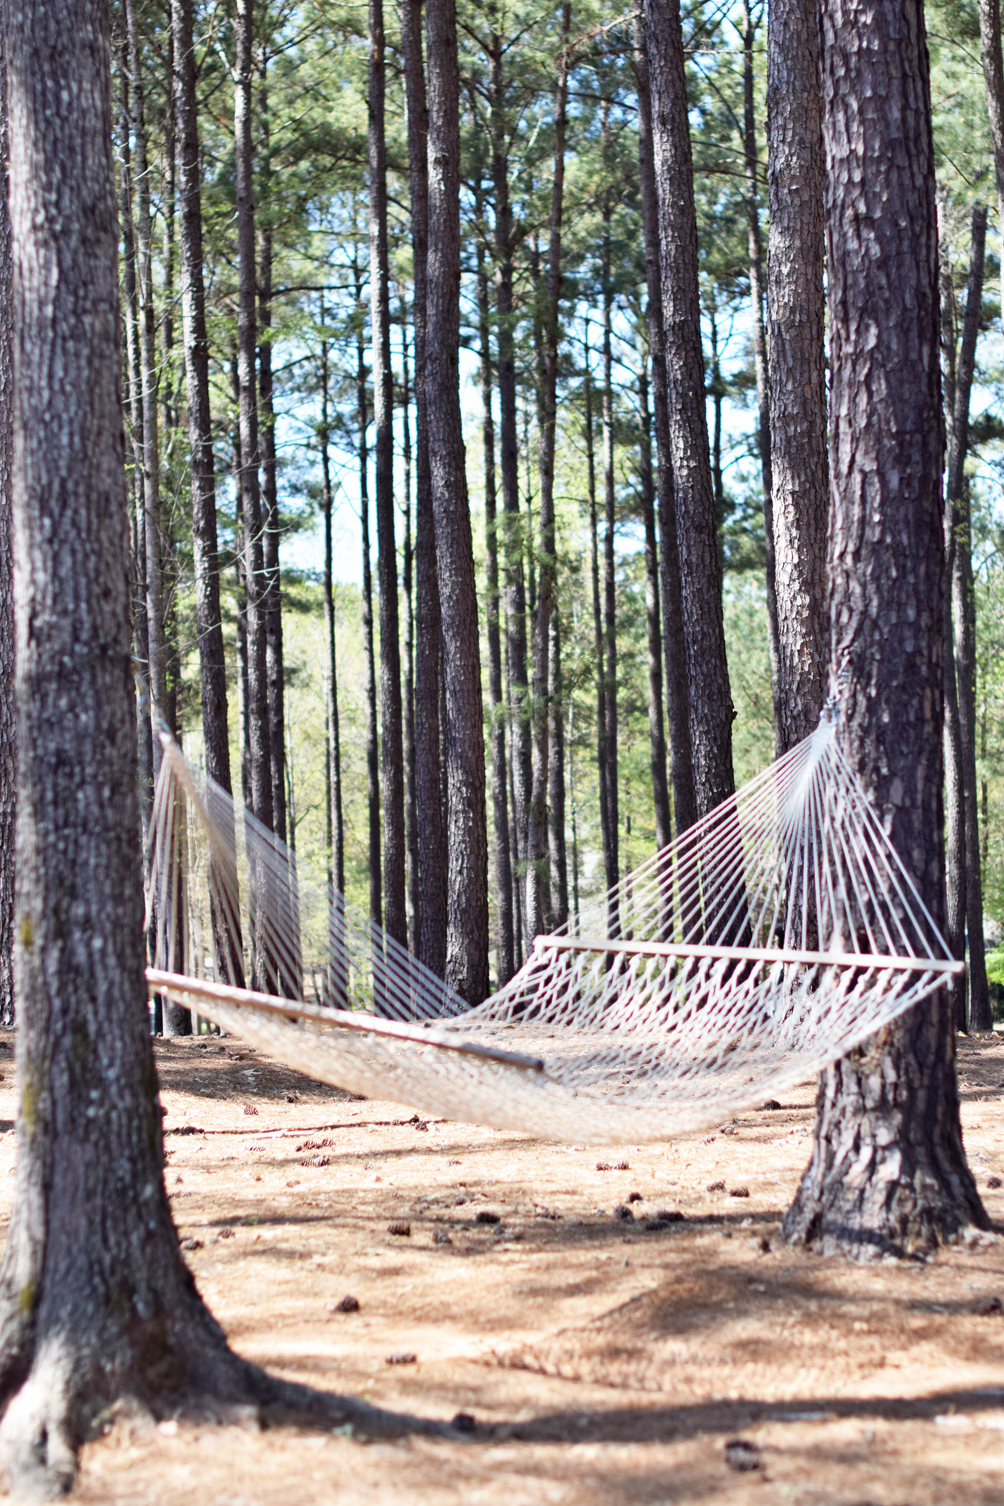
[945,205,993,1030]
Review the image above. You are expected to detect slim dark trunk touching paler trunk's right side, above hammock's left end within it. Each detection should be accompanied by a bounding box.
[257,41,294,845]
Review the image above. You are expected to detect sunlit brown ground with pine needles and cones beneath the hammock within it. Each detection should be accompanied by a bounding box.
[0,1036,1004,1506]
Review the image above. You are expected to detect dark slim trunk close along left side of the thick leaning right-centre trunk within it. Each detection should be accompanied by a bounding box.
[634,11,697,831]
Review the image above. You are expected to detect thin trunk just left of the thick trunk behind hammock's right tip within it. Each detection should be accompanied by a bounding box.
[742,0,784,758]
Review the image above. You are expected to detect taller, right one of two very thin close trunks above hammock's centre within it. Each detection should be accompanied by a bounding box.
[602,197,620,909]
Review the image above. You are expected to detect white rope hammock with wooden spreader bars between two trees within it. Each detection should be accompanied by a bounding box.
[148,712,963,1145]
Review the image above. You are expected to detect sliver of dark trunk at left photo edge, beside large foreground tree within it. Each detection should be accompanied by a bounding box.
[0,35,17,1027]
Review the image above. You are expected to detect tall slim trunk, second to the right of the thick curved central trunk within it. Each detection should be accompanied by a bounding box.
[488,33,533,925]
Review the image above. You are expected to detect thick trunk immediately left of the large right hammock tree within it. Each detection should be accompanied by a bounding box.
[768,0,829,753]
